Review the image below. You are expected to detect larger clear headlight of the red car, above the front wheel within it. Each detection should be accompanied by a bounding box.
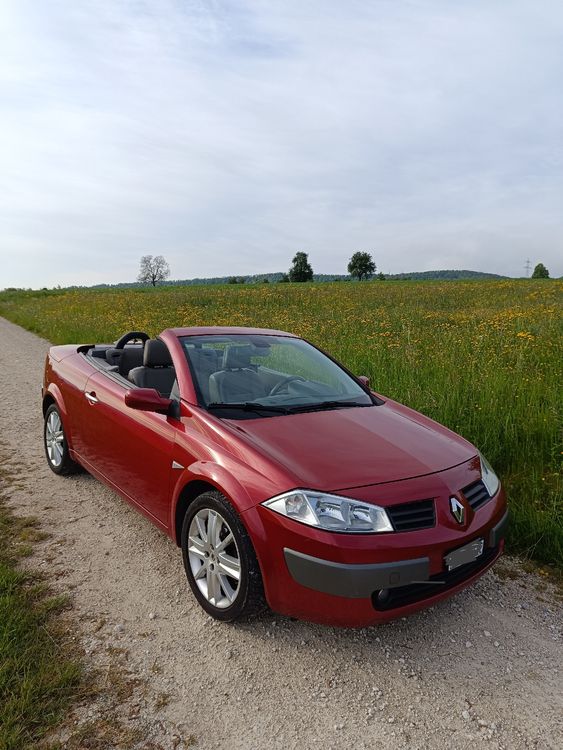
[262,490,393,534]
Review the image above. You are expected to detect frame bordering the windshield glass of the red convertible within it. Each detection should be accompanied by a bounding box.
[178,331,384,420]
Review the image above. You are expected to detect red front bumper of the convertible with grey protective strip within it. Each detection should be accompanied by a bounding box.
[242,467,508,627]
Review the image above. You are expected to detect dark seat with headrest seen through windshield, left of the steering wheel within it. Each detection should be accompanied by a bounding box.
[209,346,269,403]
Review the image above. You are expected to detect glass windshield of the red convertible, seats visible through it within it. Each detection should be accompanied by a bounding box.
[181,334,374,418]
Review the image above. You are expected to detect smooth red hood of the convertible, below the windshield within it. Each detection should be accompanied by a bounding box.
[225,401,477,492]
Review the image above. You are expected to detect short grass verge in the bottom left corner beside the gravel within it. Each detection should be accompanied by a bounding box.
[0,470,82,750]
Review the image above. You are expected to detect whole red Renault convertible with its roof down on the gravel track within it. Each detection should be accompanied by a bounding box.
[42,327,507,626]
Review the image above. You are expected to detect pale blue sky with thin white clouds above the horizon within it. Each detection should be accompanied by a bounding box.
[0,0,563,288]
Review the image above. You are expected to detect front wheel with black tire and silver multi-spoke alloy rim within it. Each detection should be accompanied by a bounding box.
[181,490,265,622]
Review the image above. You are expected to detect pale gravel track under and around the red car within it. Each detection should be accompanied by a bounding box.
[0,319,563,750]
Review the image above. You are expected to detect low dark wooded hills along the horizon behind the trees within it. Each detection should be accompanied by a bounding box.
[83,270,508,289]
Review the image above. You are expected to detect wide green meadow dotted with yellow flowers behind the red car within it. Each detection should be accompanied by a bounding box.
[0,280,563,566]
